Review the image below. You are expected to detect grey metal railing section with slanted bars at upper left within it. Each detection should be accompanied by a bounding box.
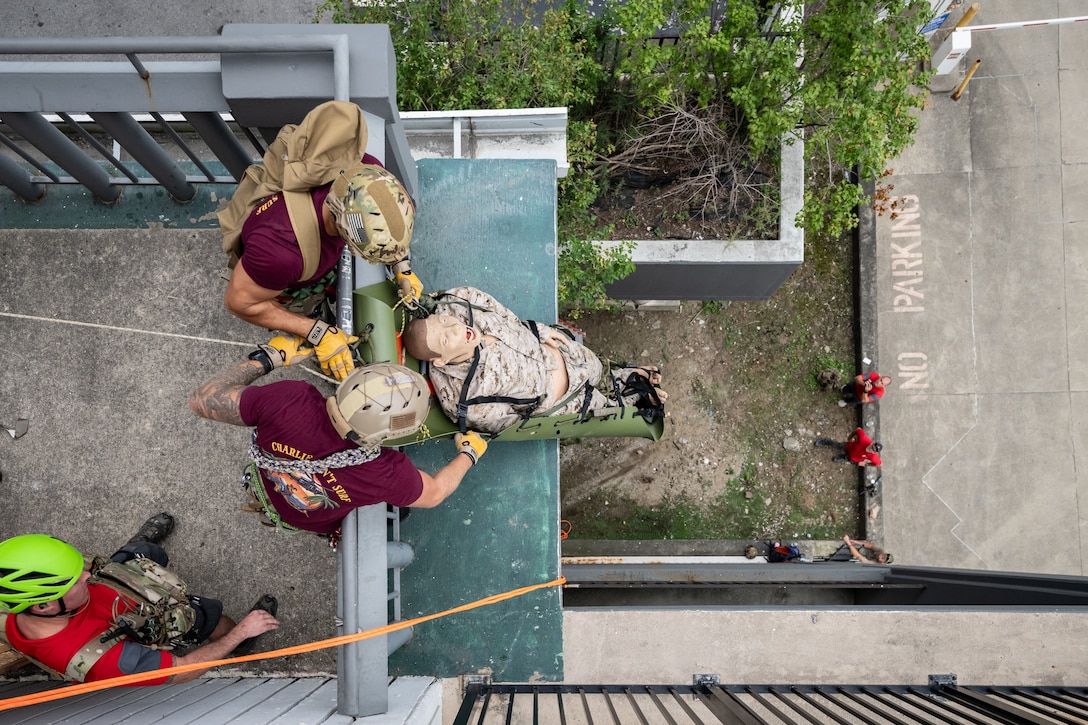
[0,34,349,202]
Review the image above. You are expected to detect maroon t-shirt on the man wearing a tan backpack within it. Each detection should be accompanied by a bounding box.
[239,153,381,291]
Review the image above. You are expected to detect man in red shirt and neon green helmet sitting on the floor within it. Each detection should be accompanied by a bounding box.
[0,513,280,685]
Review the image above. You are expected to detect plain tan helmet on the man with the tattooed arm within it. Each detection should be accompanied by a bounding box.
[326,363,431,445]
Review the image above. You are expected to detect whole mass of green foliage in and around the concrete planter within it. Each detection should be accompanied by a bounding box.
[319,0,931,293]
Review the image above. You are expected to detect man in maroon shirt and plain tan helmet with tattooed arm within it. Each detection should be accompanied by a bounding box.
[189,335,487,534]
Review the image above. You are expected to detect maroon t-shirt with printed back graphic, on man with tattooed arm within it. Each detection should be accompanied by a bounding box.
[239,380,423,533]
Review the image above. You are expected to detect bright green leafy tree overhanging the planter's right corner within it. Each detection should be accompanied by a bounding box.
[618,0,930,234]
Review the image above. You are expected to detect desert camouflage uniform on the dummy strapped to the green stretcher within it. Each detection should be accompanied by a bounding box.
[430,287,639,433]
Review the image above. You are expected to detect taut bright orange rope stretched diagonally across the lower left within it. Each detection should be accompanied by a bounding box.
[0,577,567,711]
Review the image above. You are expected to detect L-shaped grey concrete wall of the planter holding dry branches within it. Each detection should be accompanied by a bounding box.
[602,130,805,300]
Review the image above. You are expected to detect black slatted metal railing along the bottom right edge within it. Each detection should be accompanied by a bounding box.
[453,675,1088,725]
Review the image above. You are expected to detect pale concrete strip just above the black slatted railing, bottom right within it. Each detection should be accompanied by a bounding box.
[564,607,1088,686]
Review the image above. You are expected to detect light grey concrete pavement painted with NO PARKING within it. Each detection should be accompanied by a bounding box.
[863,0,1088,575]
